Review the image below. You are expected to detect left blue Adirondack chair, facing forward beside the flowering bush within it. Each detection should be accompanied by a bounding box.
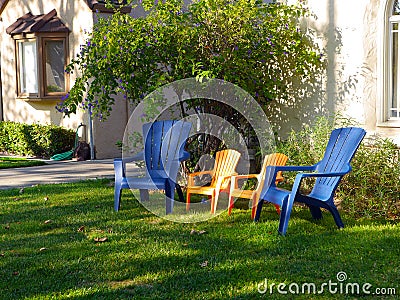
[114,120,191,214]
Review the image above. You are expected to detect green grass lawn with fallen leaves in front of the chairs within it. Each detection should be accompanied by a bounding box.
[0,180,400,299]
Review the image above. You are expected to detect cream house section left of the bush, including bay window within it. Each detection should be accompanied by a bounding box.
[0,0,134,158]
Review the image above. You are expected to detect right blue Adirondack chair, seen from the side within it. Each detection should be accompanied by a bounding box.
[254,127,366,235]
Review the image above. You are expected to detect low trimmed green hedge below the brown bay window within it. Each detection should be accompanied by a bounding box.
[0,121,75,158]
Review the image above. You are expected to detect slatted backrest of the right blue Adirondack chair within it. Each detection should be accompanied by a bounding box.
[311,127,366,198]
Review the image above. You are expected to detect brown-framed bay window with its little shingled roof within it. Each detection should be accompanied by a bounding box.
[6,10,69,100]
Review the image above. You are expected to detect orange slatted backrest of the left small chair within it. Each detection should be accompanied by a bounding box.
[210,149,240,189]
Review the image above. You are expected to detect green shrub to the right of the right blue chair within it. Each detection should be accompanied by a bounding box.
[337,136,400,219]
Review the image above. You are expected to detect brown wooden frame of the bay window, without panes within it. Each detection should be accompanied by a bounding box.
[13,32,70,101]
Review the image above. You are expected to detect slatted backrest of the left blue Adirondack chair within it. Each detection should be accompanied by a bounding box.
[143,120,192,179]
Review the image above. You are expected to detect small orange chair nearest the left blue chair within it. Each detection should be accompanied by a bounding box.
[186,149,240,214]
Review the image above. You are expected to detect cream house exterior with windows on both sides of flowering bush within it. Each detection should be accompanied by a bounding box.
[0,0,400,158]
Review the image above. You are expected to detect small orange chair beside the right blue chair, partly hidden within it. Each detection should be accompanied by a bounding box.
[228,153,288,219]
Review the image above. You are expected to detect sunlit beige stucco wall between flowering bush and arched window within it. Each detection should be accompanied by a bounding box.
[287,0,400,145]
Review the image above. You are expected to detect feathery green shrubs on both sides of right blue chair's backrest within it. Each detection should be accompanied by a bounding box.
[278,117,400,219]
